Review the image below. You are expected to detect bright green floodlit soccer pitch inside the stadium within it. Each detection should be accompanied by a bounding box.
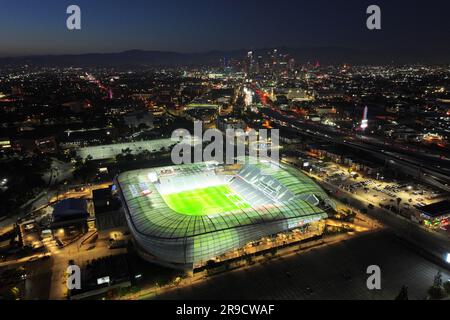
[162,185,250,216]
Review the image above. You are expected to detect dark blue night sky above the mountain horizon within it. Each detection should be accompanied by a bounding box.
[0,0,450,56]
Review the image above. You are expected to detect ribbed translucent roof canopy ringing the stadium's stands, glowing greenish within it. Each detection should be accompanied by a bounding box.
[117,162,332,239]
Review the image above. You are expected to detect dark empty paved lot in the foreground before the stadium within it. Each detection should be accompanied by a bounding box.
[158,231,450,300]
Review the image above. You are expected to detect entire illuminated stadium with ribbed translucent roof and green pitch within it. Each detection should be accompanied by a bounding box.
[116,159,334,270]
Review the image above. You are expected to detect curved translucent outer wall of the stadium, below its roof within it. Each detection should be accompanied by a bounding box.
[115,161,327,270]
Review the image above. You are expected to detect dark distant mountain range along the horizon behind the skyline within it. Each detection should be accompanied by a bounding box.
[0,45,450,67]
